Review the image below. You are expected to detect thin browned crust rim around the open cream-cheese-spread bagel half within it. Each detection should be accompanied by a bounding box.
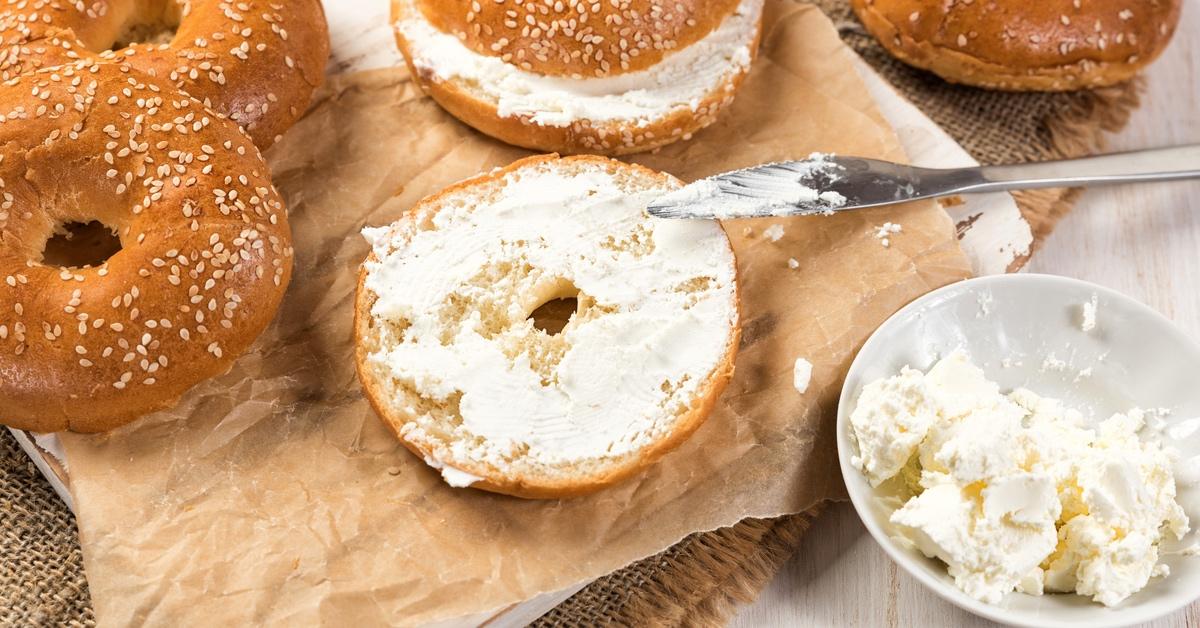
[354,155,742,500]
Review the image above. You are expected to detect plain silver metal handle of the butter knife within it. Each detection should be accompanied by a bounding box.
[960,144,1200,192]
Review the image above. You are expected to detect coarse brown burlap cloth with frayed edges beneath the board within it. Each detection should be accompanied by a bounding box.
[0,0,1139,626]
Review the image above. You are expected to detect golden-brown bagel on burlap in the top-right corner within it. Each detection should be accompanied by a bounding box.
[851,0,1182,91]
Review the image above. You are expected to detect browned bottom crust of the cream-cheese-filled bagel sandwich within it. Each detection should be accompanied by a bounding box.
[391,0,762,156]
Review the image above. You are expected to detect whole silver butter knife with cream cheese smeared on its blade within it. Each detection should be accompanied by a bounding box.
[647,144,1200,220]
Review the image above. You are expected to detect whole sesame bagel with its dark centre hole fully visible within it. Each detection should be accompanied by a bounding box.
[0,59,292,432]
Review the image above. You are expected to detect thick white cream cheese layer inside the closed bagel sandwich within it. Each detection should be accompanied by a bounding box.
[396,0,763,127]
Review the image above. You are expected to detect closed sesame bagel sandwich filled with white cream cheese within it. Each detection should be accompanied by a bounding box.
[392,0,763,155]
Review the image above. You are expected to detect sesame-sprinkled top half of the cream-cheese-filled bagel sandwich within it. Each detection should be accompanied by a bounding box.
[418,0,738,78]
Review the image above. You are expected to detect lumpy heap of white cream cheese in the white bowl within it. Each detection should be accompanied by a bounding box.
[850,352,1188,606]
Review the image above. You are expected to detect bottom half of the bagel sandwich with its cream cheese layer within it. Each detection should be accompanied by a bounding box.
[392,0,763,155]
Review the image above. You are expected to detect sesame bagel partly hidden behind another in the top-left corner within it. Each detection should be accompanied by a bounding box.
[0,0,329,150]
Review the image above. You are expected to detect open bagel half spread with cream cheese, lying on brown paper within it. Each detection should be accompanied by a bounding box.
[355,155,740,498]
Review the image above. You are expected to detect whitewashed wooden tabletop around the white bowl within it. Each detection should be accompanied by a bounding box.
[732,11,1200,628]
